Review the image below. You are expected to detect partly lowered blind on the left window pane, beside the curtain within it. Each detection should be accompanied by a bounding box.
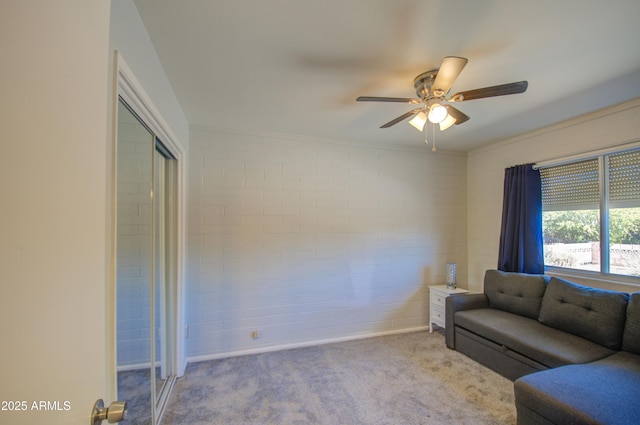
[540,158,600,211]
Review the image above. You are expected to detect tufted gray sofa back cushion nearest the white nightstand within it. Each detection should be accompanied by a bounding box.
[484,270,548,319]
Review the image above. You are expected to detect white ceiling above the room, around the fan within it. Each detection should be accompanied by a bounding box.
[135,0,640,151]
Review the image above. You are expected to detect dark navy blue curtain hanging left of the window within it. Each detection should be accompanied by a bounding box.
[498,164,544,273]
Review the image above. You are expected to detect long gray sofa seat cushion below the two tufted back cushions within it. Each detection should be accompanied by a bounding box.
[454,308,615,368]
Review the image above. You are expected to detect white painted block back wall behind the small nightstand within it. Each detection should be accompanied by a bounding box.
[187,127,467,360]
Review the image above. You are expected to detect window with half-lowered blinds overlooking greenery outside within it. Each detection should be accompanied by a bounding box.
[540,149,640,276]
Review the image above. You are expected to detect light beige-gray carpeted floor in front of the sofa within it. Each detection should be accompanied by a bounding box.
[162,332,515,425]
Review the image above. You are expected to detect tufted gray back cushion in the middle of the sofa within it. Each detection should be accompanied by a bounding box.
[539,277,629,350]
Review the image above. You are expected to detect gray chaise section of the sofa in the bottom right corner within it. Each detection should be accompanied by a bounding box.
[514,351,640,425]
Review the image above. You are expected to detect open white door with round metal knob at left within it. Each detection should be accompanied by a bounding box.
[0,0,110,425]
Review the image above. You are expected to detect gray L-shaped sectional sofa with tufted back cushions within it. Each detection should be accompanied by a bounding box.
[445,270,640,425]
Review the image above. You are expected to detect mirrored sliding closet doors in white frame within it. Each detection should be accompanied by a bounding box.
[116,99,177,425]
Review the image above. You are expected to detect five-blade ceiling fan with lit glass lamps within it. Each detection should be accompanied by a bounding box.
[356,56,529,131]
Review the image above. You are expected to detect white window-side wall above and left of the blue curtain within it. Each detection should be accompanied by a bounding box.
[467,99,640,292]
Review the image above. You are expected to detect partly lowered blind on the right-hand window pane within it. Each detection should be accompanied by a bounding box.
[609,149,640,208]
